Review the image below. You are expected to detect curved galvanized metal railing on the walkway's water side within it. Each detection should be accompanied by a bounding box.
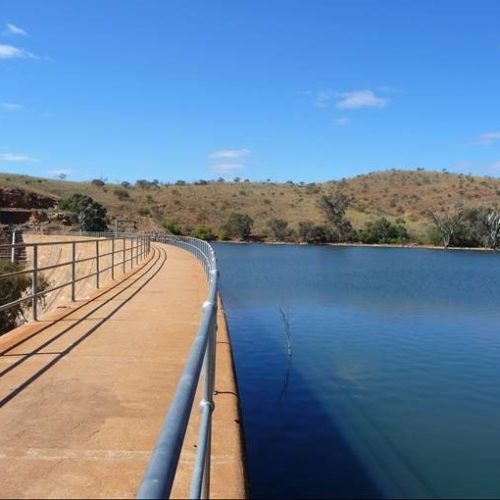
[137,236,218,499]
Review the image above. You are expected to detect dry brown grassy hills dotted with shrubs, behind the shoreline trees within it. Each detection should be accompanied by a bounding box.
[0,169,500,242]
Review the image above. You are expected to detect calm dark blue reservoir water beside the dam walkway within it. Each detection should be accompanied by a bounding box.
[216,244,500,498]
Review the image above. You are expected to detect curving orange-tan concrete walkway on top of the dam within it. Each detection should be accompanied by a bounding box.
[0,245,245,498]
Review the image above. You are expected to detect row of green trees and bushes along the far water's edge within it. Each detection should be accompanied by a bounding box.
[163,190,500,249]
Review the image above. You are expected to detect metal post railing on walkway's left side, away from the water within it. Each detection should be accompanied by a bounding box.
[0,233,150,321]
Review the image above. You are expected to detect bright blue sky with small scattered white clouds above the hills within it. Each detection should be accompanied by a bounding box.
[0,0,500,182]
